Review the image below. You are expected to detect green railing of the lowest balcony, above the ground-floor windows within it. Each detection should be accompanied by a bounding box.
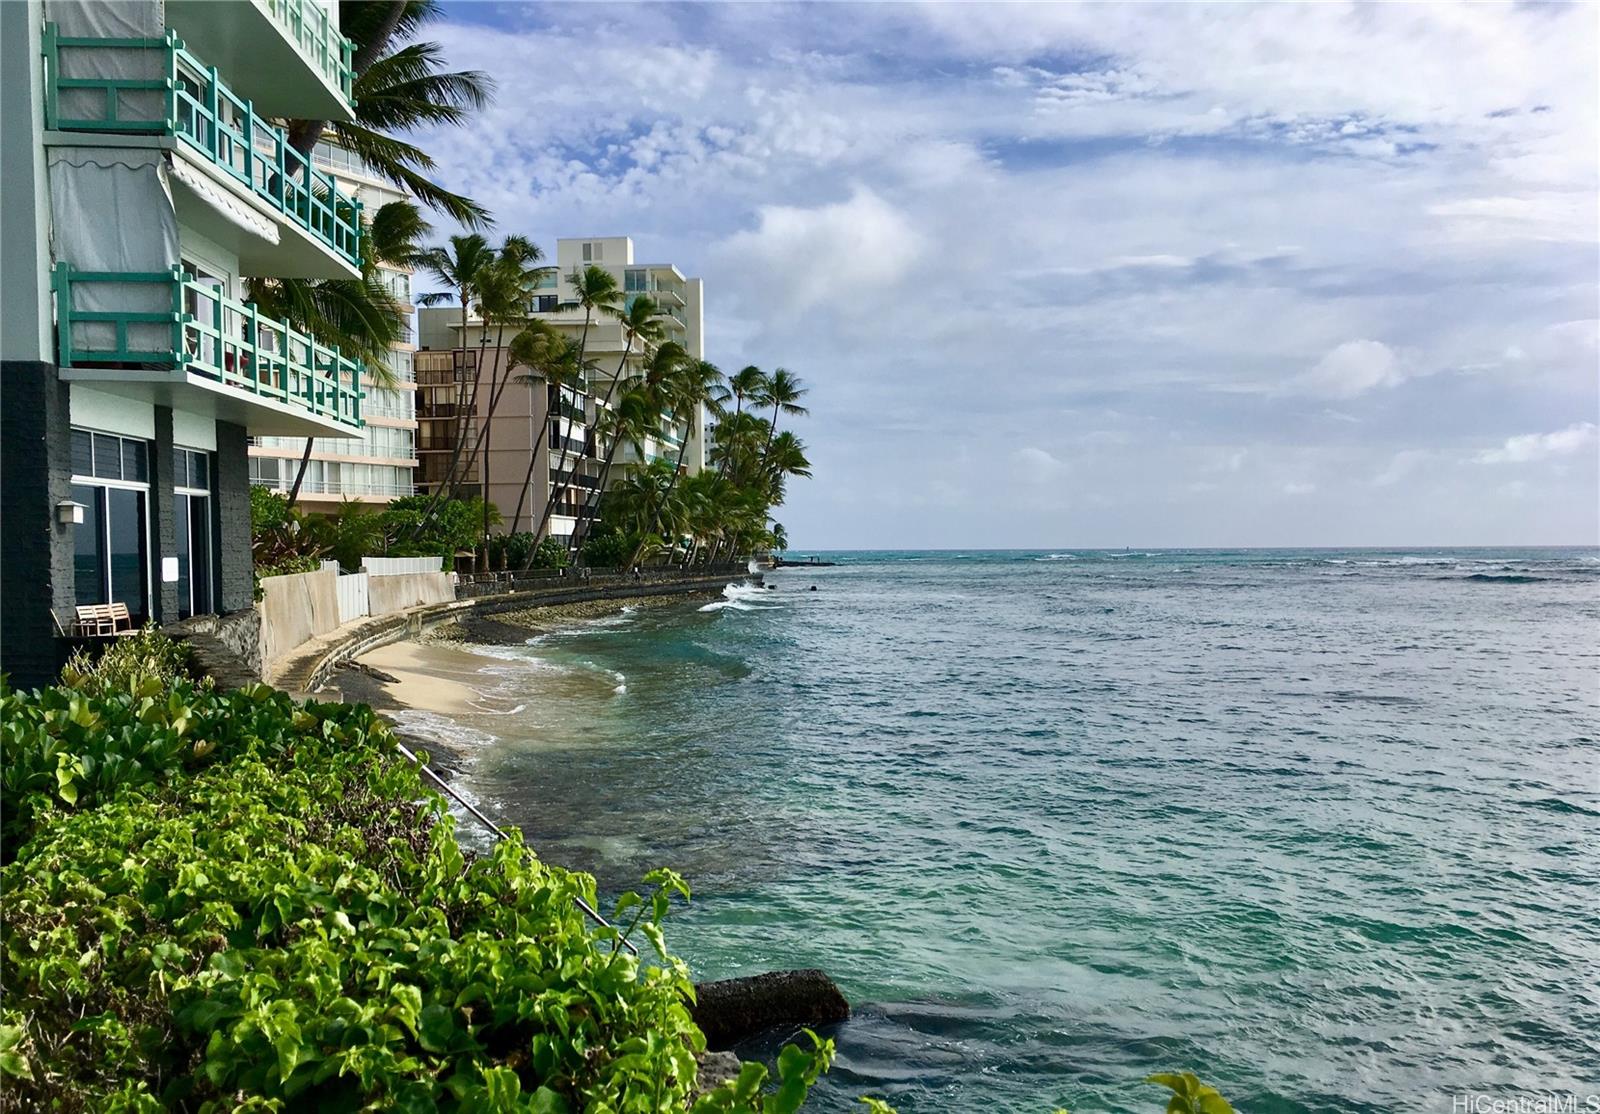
[51,262,362,429]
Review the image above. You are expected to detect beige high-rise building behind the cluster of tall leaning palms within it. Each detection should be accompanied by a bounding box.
[416,235,706,538]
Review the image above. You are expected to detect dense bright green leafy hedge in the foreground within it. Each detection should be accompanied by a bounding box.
[0,649,832,1114]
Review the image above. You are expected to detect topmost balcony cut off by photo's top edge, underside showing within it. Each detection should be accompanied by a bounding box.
[166,0,355,120]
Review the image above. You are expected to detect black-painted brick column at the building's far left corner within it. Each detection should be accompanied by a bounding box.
[0,360,77,688]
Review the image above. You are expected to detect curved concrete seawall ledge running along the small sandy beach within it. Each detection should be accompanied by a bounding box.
[266,573,742,695]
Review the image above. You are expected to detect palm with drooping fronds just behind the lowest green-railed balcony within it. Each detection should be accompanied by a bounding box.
[246,202,429,507]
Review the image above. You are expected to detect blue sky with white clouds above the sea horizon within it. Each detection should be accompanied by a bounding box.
[421,3,1600,551]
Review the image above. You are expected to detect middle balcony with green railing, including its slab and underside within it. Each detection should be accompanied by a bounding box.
[45,25,362,279]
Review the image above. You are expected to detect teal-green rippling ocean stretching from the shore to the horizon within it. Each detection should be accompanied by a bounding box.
[390,549,1600,1114]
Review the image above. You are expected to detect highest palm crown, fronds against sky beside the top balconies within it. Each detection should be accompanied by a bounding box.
[286,0,494,227]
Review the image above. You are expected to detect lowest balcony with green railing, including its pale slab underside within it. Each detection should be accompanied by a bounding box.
[51,262,362,437]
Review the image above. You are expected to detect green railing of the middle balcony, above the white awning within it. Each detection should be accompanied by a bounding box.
[45,24,362,267]
